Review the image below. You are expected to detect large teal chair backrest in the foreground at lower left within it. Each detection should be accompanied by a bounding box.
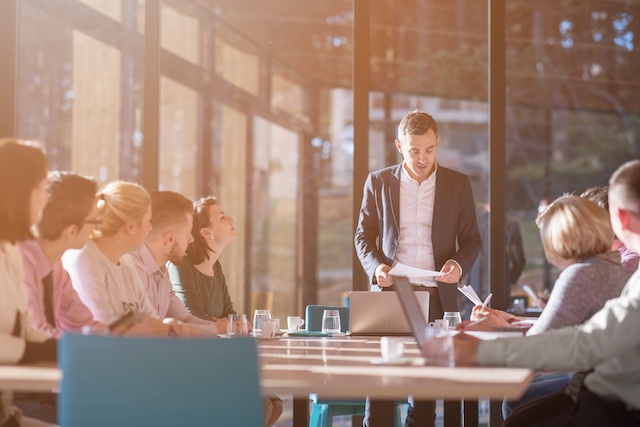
[58,334,264,427]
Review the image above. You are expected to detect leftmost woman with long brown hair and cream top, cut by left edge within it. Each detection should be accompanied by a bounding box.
[0,139,56,427]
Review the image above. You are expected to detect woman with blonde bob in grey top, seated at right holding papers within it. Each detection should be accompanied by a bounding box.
[463,195,630,418]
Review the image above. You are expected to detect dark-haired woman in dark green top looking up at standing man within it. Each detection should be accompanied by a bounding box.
[168,196,282,427]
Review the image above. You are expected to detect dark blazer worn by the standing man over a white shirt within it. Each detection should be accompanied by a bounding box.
[354,163,482,311]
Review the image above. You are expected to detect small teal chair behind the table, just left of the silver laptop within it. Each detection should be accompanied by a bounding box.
[305,305,407,427]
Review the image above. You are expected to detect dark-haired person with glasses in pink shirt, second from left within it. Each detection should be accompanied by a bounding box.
[20,172,103,338]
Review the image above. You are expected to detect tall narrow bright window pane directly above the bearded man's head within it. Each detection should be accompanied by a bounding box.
[159,77,198,198]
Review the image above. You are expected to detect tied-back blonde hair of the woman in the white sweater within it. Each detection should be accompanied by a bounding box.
[91,181,151,240]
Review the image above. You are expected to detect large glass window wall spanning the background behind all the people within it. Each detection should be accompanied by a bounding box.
[7,0,640,324]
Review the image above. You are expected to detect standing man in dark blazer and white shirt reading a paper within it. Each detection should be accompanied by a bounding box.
[355,111,482,320]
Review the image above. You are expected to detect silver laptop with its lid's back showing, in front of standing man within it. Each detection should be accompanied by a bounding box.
[349,285,429,336]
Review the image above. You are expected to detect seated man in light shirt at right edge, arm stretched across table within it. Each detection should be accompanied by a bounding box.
[454,160,640,427]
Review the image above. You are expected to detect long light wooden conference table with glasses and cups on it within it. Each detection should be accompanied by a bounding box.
[0,334,533,427]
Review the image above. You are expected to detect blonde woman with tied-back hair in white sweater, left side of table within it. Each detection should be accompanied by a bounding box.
[62,181,198,336]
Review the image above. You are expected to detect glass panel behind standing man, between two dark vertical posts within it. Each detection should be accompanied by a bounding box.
[369,0,489,317]
